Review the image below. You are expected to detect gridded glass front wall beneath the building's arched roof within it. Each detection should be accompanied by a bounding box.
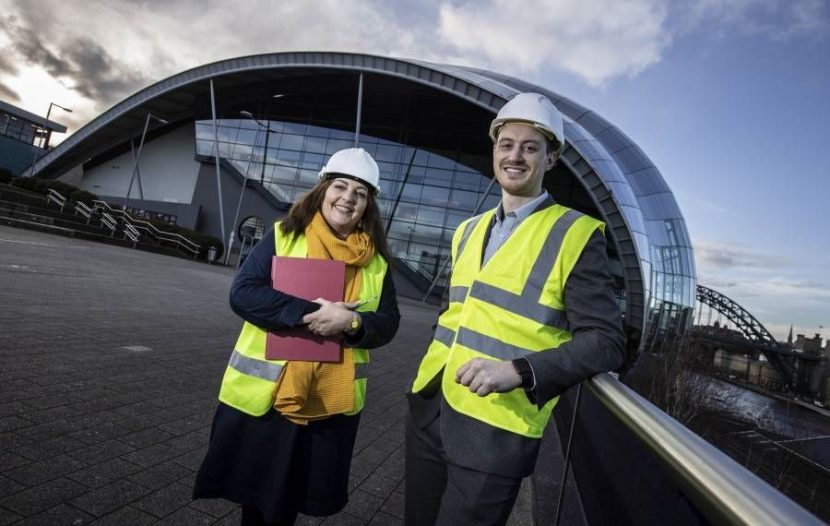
[196,119,499,289]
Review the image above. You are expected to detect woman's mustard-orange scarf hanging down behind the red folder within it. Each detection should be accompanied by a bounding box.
[274,211,375,425]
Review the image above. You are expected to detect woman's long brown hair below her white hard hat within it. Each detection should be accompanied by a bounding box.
[280,177,392,264]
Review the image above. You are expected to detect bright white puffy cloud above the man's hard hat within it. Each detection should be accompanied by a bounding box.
[439,0,670,86]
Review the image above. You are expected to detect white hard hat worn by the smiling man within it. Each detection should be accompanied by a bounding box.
[490,93,565,151]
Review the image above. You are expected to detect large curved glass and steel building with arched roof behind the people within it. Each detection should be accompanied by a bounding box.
[29,52,696,351]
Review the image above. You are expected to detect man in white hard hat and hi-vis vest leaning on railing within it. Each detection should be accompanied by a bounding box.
[406,93,625,526]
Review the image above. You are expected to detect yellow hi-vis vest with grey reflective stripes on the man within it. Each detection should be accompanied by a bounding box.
[412,204,604,438]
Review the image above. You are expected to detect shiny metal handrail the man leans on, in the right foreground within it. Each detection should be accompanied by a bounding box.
[586,373,824,526]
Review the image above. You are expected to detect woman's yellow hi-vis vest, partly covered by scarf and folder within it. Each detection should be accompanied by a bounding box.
[219,222,387,416]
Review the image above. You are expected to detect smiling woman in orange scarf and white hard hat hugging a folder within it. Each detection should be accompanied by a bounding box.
[193,148,400,524]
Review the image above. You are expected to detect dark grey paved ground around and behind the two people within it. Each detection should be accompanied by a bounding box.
[0,226,530,525]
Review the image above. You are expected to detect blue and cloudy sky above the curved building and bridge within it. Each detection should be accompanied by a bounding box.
[0,0,830,339]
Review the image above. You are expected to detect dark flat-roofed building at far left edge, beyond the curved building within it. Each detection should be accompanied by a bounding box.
[0,100,66,175]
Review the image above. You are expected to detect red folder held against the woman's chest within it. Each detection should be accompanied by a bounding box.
[265,256,346,362]
